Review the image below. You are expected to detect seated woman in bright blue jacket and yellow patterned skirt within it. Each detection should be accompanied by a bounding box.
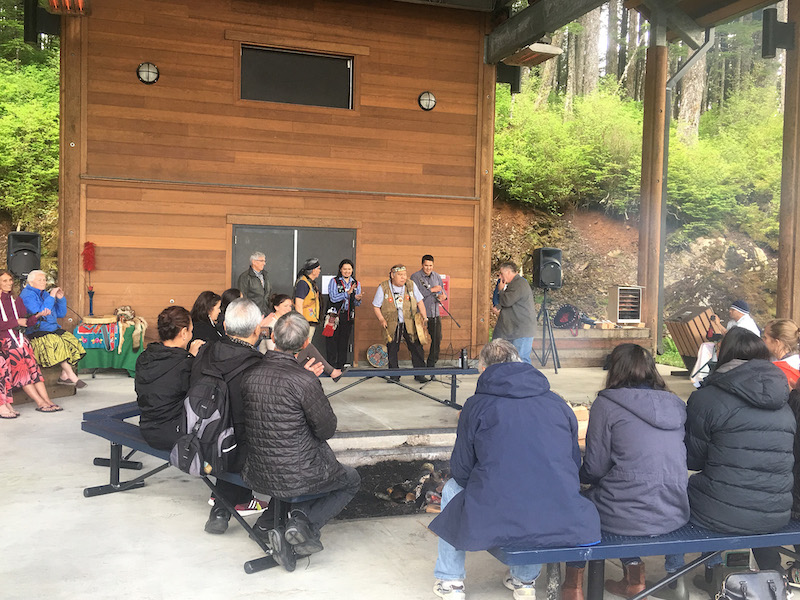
[19,271,86,388]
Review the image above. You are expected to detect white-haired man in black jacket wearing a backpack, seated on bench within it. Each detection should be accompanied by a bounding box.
[190,298,262,534]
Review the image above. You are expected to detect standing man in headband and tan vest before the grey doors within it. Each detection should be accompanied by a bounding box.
[372,265,428,383]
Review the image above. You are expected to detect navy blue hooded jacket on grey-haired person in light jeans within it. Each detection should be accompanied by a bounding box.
[429,363,600,550]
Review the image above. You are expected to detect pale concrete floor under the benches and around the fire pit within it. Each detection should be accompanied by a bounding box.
[0,369,724,600]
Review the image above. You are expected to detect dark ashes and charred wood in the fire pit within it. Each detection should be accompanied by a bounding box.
[337,460,450,519]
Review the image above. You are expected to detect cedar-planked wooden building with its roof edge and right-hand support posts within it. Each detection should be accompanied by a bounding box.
[56,0,800,366]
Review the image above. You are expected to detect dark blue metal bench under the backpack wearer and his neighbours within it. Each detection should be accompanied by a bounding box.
[81,402,282,573]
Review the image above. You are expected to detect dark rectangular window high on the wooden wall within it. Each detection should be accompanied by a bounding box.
[242,45,353,108]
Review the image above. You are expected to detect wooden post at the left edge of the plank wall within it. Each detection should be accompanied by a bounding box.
[58,16,85,318]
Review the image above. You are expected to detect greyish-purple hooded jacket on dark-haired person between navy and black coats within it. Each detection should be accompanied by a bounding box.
[580,388,689,535]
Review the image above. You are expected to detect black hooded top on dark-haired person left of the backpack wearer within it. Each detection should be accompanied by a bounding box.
[134,342,192,450]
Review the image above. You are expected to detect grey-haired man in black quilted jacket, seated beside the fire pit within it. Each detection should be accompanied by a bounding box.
[241,309,361,562]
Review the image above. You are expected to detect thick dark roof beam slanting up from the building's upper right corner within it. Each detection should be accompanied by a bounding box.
[486,0,604,65]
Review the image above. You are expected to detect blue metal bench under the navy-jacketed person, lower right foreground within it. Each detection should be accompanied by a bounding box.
[489,521,800,600]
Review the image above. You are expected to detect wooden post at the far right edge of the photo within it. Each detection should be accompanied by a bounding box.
[776,2,800,322]
